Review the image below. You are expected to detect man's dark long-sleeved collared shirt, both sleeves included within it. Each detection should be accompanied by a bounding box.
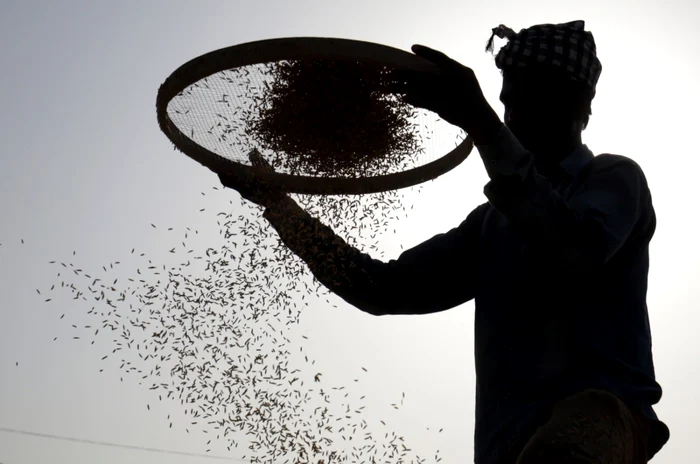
[263,125,669,464]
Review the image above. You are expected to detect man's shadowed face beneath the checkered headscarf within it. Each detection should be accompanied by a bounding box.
[500,69,572,152]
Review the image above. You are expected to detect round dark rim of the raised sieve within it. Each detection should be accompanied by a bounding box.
[156,37,474,195]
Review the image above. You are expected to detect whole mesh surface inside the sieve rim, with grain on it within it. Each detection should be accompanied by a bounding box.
[167,59,465,177]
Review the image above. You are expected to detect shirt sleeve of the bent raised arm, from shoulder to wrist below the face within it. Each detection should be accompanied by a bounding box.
[477,125,652,272]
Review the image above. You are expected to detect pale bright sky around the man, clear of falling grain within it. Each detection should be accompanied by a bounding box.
[0,0,700,464]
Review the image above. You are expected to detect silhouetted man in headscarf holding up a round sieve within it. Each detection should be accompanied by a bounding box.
[221,21,669,464]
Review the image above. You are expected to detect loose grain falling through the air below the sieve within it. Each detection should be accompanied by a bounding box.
[38,187,438,464]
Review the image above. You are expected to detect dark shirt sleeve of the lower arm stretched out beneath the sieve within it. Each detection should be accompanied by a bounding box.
[263,198,488,315]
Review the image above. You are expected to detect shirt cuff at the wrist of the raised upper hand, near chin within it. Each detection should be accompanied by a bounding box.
[475,124,532,181]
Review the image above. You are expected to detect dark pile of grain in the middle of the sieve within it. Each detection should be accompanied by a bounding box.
[245,60,421,177]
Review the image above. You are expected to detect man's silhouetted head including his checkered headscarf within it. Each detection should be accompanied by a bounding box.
[486,20,602,163]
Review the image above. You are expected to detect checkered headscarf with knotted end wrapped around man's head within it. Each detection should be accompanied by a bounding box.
[486,20,603,90]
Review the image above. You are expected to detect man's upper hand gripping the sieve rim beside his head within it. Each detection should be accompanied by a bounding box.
[392,45,501,145]
